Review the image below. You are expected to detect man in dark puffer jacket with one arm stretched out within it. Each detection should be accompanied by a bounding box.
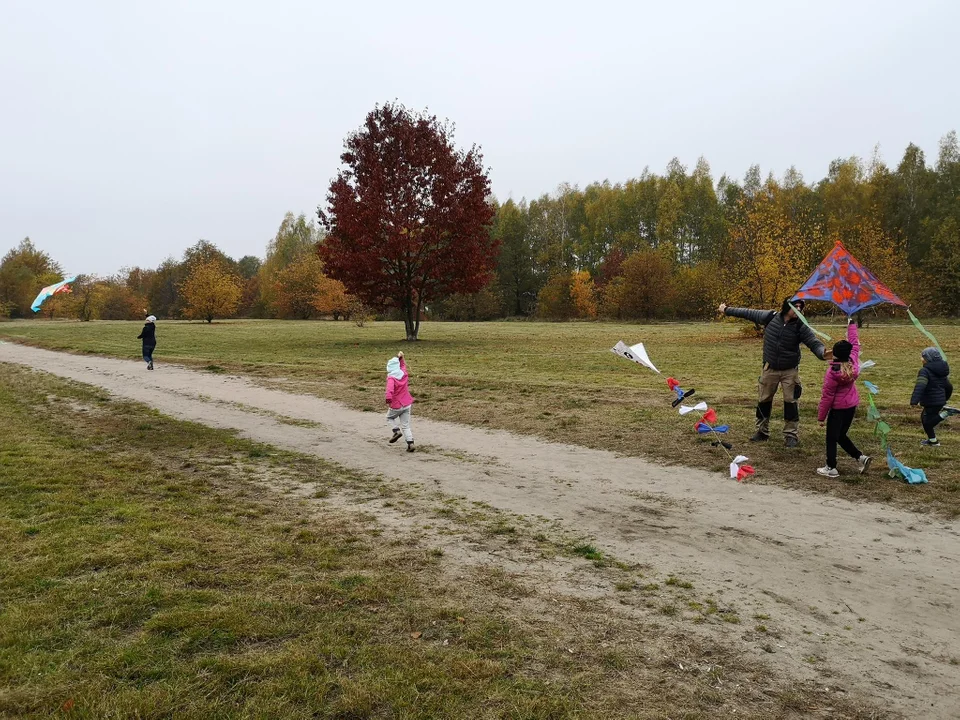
[720,298,830,447]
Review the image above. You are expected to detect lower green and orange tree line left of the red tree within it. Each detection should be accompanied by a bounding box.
[0,213,362,322]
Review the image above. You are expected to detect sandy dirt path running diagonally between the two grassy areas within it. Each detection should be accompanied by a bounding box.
[0,342,960,718]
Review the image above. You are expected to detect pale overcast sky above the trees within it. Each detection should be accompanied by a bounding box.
[0,0,960,273]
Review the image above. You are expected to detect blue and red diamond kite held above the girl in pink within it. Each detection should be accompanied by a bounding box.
[793,241,907,315]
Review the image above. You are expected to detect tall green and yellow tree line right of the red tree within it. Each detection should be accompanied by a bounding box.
[492,132,960,319]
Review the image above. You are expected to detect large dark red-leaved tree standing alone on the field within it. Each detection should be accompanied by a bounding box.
[317,103,497,340]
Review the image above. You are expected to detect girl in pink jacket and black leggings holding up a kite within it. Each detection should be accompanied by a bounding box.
[817,318,872,477]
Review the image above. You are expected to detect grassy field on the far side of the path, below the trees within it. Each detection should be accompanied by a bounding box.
[0,321,960,517]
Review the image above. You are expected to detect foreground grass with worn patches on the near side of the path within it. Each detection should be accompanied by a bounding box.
[0,362,880,719]
